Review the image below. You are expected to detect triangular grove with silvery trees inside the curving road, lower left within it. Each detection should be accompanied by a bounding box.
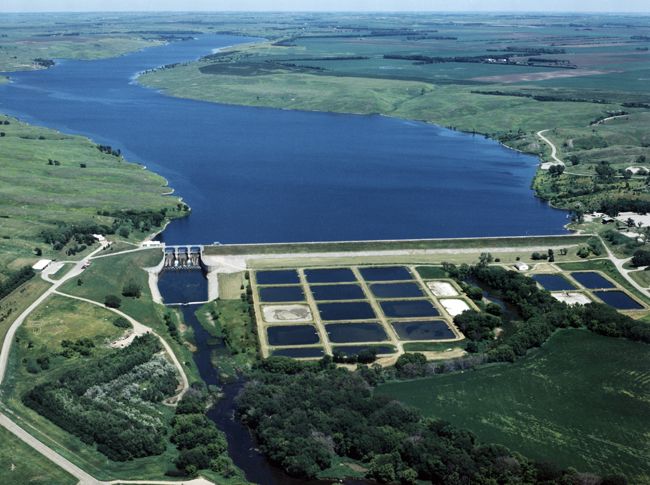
[22,334,178,461]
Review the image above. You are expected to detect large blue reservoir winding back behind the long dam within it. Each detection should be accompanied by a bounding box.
[0,34,566,244]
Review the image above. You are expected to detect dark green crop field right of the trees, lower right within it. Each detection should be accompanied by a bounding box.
[377,330,650,484]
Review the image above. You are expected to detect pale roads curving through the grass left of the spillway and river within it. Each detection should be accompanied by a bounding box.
[0,246,197,485]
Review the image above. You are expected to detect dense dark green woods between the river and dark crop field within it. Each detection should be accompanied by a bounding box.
[238,354,625,485]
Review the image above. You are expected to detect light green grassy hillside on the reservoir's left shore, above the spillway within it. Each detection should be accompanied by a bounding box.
[0,115,182,277]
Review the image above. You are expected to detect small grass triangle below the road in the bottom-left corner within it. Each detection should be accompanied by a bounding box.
[0,428,78,485]
